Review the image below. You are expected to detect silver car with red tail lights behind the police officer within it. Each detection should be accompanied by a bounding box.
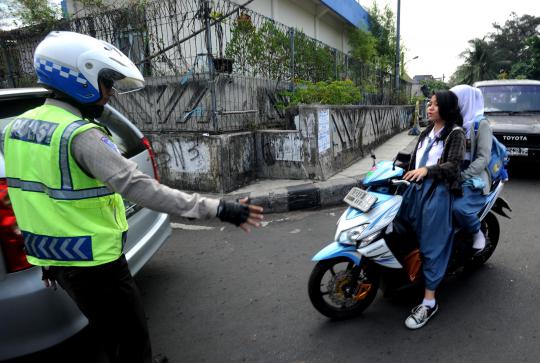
[0,88,171,361]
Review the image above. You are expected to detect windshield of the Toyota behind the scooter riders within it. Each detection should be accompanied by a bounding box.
[478,85,540,112]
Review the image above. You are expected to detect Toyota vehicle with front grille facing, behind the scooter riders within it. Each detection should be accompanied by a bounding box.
[474,80,540,164]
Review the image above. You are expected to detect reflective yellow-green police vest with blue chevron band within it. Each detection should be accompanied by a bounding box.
[3,105,128,266]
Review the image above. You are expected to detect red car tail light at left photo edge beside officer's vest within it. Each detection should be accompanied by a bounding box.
[0,179,32,272]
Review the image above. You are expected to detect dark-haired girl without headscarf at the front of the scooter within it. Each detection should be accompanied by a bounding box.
[398,91,465,329]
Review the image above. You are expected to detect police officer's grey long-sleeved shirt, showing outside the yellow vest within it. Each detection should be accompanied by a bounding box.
[47,99,219,218]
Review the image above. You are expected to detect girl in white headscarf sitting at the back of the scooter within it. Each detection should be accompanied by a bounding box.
[451,84,492,252]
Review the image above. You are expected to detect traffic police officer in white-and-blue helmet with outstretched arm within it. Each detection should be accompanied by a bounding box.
[3,31,262,363]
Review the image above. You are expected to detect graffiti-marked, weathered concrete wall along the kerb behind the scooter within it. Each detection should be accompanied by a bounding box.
[143,106,414,193]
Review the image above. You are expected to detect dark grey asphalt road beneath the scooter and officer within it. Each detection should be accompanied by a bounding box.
[7,166,540,363]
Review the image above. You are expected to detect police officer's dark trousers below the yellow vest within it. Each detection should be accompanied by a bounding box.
[51,255,152,363]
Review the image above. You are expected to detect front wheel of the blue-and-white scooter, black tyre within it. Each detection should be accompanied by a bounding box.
[308,257,380,319]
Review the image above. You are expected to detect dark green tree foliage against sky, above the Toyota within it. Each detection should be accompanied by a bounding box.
[451,13,540,84]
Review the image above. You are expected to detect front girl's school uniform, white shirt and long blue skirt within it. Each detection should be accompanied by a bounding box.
[398,124,465,290]
